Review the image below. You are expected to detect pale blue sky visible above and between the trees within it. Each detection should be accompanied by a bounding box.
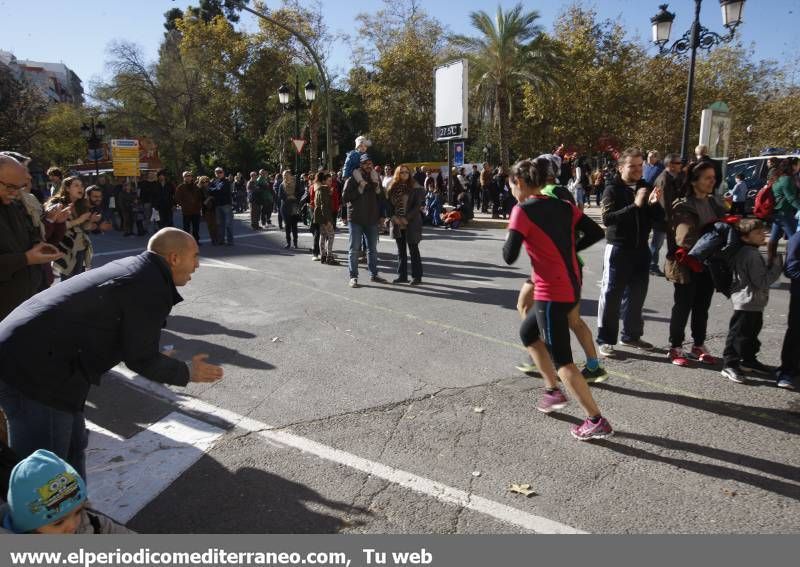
[0,0,800,91]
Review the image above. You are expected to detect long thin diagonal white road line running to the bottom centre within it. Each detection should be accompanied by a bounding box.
[112,365,587,534]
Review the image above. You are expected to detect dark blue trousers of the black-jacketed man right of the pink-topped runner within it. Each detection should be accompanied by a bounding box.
[597,244,650,345]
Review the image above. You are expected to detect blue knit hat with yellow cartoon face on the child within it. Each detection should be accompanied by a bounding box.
[7,449,86,533]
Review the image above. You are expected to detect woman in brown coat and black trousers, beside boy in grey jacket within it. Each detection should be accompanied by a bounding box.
[664,162,725,366]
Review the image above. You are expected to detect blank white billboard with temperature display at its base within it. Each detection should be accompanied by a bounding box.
[434,59,469,141]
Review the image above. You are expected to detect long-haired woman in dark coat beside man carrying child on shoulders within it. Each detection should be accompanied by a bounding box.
[387,165,425,285]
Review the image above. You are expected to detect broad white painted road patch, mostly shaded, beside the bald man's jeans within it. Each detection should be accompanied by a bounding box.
[86,412,224,524]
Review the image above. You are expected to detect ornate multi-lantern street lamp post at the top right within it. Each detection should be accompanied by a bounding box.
[650,0,745,159]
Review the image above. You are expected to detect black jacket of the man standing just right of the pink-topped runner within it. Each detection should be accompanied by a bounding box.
[600,176,664,250]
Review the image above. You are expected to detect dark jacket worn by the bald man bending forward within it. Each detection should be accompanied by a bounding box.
[0,252,189,412]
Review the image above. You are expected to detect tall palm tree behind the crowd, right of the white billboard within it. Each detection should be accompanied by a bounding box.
[450,4,559,166]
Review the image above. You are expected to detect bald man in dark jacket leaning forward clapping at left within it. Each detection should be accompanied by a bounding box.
[0,228,222,475]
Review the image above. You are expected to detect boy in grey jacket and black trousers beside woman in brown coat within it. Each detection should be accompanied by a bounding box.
[722,219,782,384]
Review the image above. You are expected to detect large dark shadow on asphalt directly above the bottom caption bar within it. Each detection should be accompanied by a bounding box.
[128,455,370,534]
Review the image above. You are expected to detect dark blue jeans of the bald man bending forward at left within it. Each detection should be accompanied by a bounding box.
[0,380,89,479]
